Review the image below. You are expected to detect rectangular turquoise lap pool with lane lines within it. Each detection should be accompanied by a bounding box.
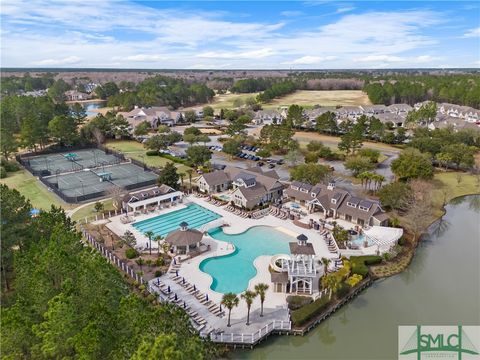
[133,204,221,237]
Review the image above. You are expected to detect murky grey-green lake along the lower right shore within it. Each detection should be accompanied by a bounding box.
[237,195,480,360]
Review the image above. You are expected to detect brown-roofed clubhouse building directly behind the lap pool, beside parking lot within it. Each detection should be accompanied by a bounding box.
[197,166,284,209]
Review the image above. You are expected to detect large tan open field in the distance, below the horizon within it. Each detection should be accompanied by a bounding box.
[263,90,372,109]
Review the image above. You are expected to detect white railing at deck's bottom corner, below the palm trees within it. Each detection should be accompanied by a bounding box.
[200,320,292,345]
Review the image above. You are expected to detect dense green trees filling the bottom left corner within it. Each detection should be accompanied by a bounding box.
[0,185,217,359]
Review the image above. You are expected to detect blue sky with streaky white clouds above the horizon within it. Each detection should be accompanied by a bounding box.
[0,0,480,70]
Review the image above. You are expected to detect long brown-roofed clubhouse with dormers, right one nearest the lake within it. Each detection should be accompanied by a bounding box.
[284,181,388,226]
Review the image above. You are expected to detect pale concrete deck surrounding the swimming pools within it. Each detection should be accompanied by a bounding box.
[107,195,400,338]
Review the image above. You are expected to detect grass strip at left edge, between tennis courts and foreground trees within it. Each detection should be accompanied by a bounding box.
[0,170,75,210]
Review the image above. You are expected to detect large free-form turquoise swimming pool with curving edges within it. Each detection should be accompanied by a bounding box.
[199,226,296,294]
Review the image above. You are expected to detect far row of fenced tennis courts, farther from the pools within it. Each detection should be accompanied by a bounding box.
[22,149,124,176]
